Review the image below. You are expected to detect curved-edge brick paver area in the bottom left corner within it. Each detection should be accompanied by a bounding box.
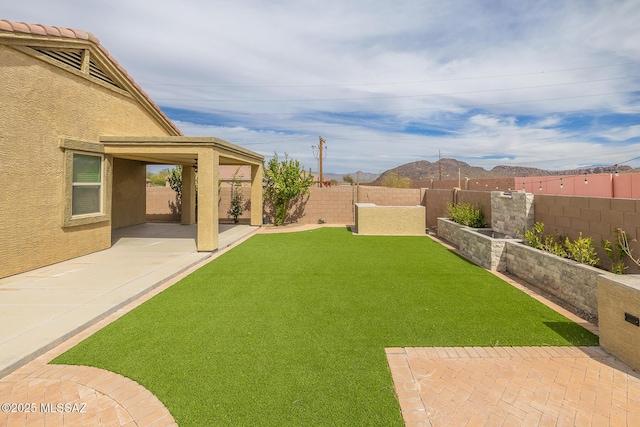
[0,363,177,427]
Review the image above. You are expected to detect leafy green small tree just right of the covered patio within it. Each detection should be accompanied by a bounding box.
[263,153,313,225]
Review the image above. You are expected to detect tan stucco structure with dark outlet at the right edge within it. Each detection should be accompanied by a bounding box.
[598,275,640,371]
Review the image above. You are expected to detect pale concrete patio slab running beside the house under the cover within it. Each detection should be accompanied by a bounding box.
[0,224,258,377]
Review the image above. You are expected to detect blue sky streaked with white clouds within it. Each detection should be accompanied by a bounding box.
[5,0,640,173]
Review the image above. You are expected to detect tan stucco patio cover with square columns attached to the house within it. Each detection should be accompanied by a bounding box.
[100,136,264,252]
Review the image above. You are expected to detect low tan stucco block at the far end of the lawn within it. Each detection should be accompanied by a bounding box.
[356,203,425,236]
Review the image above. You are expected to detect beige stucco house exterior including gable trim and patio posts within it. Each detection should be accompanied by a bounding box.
[0,27,263,278]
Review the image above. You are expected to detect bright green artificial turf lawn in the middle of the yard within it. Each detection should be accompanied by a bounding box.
[54,228,598,427]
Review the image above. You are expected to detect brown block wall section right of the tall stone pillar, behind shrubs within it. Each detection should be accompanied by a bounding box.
[535,195,640,274]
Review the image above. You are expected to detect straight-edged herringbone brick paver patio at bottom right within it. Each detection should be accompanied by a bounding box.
[387,347,640,427]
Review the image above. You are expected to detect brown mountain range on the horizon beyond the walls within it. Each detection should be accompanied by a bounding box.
[372,158,632,185]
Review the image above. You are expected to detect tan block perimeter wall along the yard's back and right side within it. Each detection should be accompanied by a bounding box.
[147,184,640,273]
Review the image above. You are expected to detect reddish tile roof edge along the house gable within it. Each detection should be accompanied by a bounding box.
[0,19,183,136]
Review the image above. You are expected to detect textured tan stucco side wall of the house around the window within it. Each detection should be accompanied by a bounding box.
[0,45,168,277]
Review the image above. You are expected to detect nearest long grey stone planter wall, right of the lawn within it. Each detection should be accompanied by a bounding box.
[506,242,610,317]
